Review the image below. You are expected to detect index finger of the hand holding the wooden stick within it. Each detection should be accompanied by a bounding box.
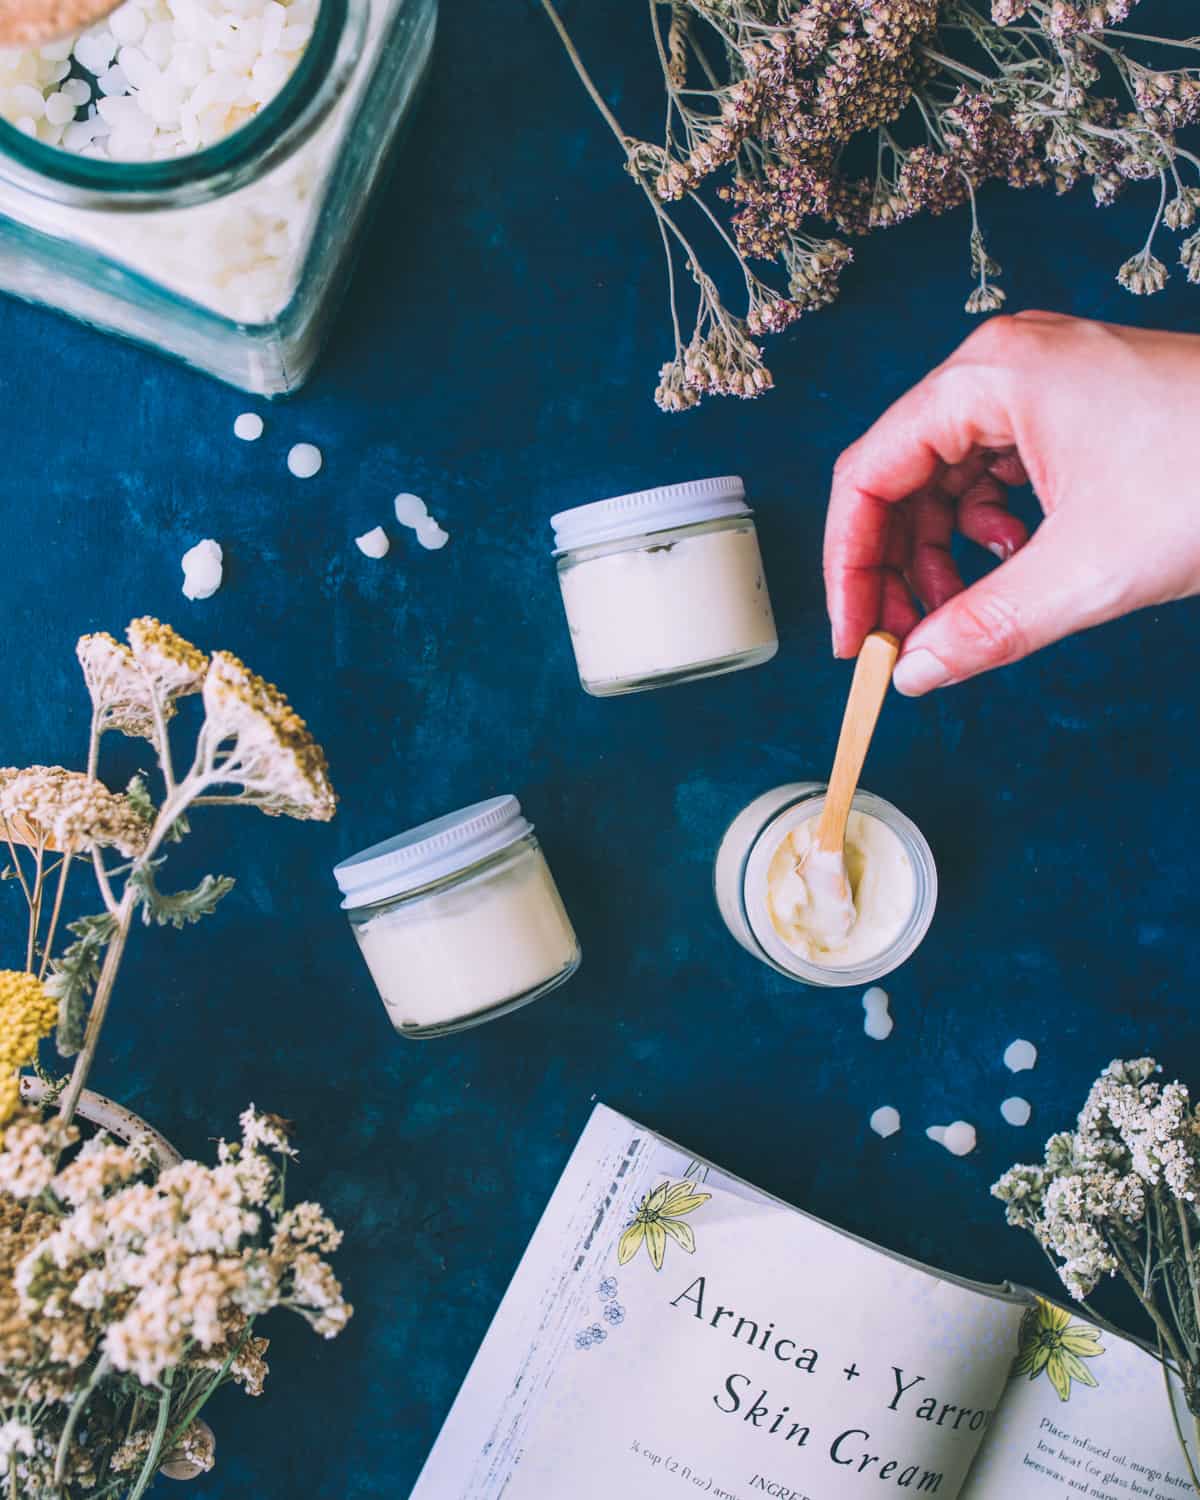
[825,350,1014,657]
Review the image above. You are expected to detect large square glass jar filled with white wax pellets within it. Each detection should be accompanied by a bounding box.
[0,0,438,396]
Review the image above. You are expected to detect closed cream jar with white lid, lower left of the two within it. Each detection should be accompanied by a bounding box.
[333,797,581,1037]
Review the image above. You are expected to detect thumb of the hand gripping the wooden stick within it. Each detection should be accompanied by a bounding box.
[893,516,1116,698]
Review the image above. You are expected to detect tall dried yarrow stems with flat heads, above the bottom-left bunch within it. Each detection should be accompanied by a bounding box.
[0,615,338,1121]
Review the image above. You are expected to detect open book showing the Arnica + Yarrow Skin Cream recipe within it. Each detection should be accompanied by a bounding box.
[413,1106,1194,1500]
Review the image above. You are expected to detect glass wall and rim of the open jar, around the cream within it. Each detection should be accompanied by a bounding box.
[714,782,938,987]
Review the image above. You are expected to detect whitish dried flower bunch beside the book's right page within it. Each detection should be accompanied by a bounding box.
[992,1058,1200,1493]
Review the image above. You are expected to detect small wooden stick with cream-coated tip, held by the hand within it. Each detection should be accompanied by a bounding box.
[800,630,900,942]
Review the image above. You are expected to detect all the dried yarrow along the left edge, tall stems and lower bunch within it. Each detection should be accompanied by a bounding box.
[0,618,350,1500]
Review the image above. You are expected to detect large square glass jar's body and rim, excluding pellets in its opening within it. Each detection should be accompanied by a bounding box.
[0,0,438,396]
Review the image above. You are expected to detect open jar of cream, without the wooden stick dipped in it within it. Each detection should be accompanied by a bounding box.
[714,782,938,987]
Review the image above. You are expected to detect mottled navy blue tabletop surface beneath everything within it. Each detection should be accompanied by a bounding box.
[0,0,1200,1500]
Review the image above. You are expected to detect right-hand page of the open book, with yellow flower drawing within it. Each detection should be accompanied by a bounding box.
[963,1299,1196,1500]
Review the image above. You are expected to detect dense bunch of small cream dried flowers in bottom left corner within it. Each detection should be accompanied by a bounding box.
[0,1107,351,1500]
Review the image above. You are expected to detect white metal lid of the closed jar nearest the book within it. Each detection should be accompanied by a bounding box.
[333,797,533,908]
